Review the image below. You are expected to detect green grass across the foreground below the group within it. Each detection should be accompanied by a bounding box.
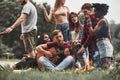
[0,55,120,80]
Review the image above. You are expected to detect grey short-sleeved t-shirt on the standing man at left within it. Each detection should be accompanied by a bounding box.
[21,2,37,33]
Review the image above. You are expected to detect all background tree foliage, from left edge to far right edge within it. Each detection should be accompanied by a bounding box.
[0,0,120,58]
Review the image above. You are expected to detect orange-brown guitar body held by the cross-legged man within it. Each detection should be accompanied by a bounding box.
[36,47,57,69]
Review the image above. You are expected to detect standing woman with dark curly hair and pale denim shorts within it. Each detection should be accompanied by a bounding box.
[89,3,113,68]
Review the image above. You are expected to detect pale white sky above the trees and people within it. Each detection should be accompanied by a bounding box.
[34,0,120,24]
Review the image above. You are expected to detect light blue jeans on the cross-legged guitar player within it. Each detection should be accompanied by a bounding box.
[39,56,75,70]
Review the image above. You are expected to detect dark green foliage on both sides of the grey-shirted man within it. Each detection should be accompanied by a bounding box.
[0,0,55,58]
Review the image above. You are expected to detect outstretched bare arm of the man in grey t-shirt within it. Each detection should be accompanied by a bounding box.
[5,13,27,33]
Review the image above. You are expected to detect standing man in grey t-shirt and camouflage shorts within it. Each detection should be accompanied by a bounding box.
[5,0,37,58]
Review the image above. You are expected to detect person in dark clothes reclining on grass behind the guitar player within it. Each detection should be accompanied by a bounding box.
[13,33,51,70]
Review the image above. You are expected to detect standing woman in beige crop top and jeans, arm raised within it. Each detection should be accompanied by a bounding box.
[40,0,69,41]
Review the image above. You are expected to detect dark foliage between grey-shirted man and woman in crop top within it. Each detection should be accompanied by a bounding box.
[36,3,55,34]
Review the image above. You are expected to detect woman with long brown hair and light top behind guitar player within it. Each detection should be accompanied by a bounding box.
[68,12,82,42]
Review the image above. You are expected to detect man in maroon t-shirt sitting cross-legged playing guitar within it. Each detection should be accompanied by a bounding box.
[36,29,75,71]
